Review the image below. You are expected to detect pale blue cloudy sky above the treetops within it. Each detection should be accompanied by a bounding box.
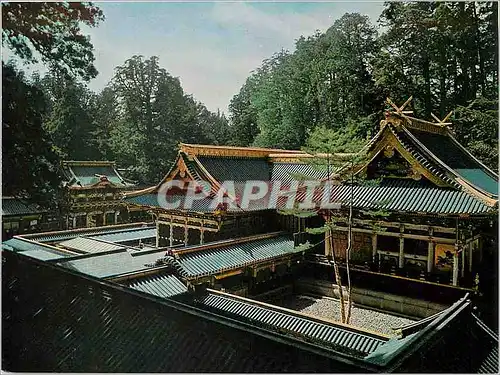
[6,1,383,114]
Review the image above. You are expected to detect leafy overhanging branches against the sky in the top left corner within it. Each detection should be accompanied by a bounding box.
[2,2,104,80]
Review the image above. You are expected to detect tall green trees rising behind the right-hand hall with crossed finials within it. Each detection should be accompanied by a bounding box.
[229,2,498,169]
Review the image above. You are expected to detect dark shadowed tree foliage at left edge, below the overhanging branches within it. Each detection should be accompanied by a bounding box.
[2,63,61,205]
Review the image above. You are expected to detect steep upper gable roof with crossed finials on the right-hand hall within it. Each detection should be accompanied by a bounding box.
[365,112,498,206]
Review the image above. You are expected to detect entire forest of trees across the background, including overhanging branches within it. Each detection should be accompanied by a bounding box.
[2,2,498,209]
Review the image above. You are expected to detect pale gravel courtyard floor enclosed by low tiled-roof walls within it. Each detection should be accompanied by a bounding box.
[269,295,414,335]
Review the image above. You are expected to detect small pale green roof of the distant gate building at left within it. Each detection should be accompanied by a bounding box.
[62,161,135,188]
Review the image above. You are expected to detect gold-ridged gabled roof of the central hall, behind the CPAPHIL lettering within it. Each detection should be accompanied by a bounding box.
[125,144,327,213]
